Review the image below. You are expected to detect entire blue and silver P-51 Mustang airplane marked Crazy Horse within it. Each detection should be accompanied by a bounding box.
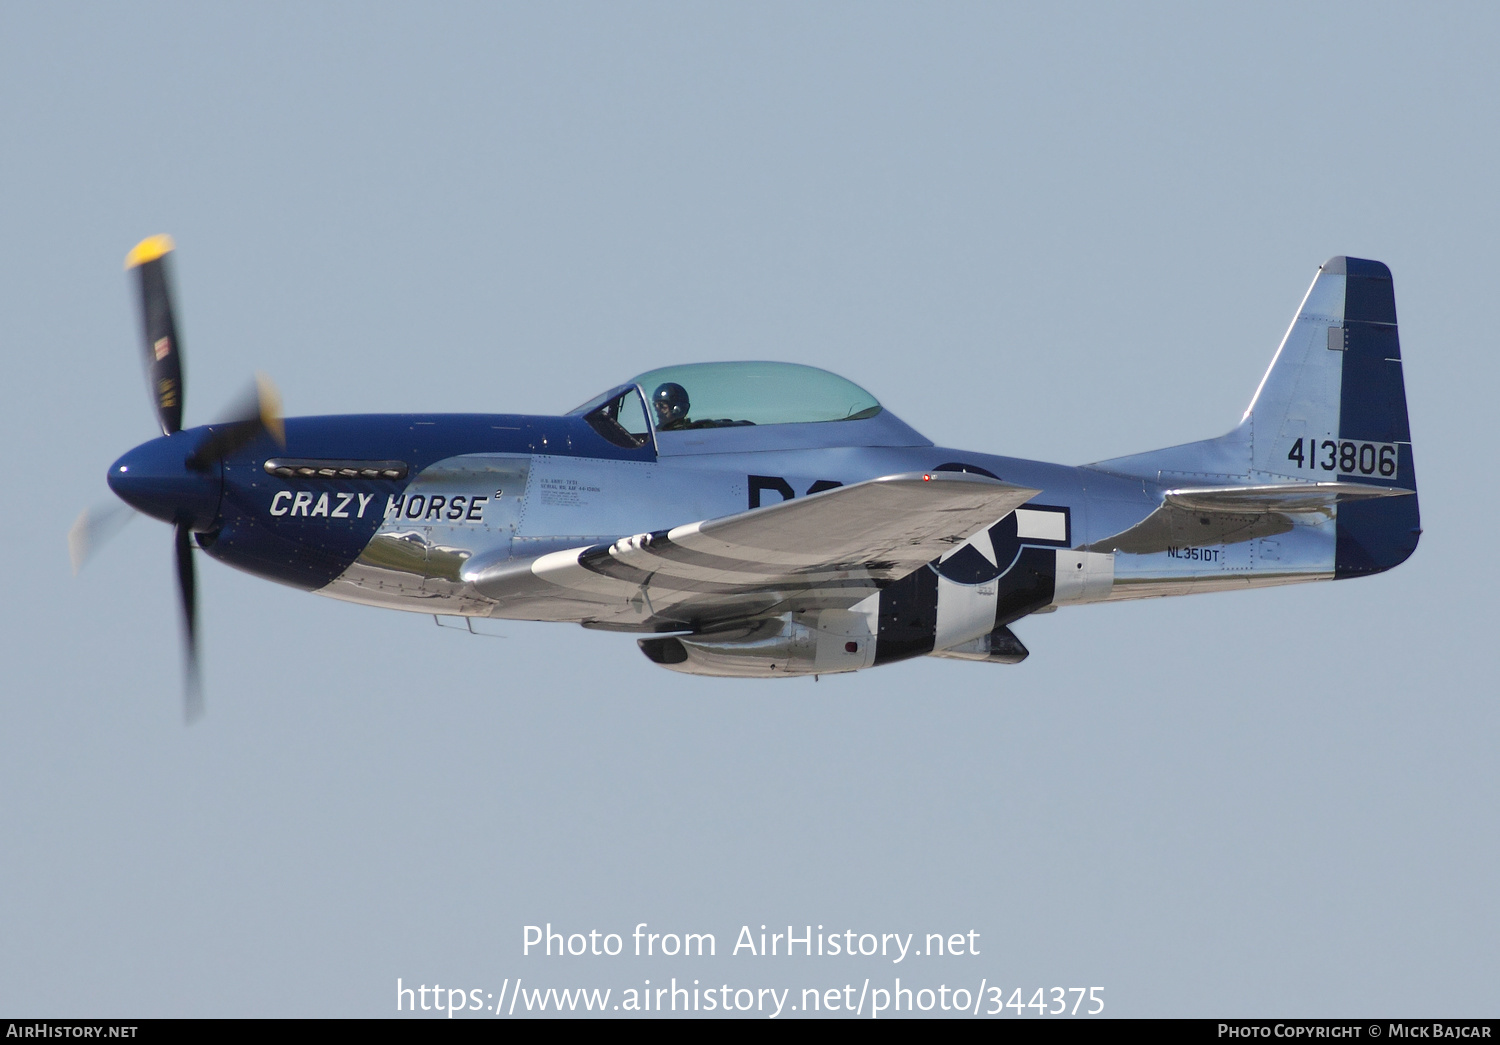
[90,237,1421,713]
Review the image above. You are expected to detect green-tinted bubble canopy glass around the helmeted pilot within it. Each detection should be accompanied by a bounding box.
[632,363,881,430]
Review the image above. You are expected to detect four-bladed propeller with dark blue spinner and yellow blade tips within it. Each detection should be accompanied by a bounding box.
[68,235,287,723]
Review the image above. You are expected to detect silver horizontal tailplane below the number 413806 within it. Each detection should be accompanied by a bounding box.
[1085,483,1413,555]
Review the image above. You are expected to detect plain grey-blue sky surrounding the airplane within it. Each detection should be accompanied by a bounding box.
[0,3,1500,1017]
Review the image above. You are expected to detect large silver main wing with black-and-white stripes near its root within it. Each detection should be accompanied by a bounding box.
[464,472,1038,630]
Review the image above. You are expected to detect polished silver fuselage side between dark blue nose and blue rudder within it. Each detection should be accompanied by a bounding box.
[320,418,1335,631]
